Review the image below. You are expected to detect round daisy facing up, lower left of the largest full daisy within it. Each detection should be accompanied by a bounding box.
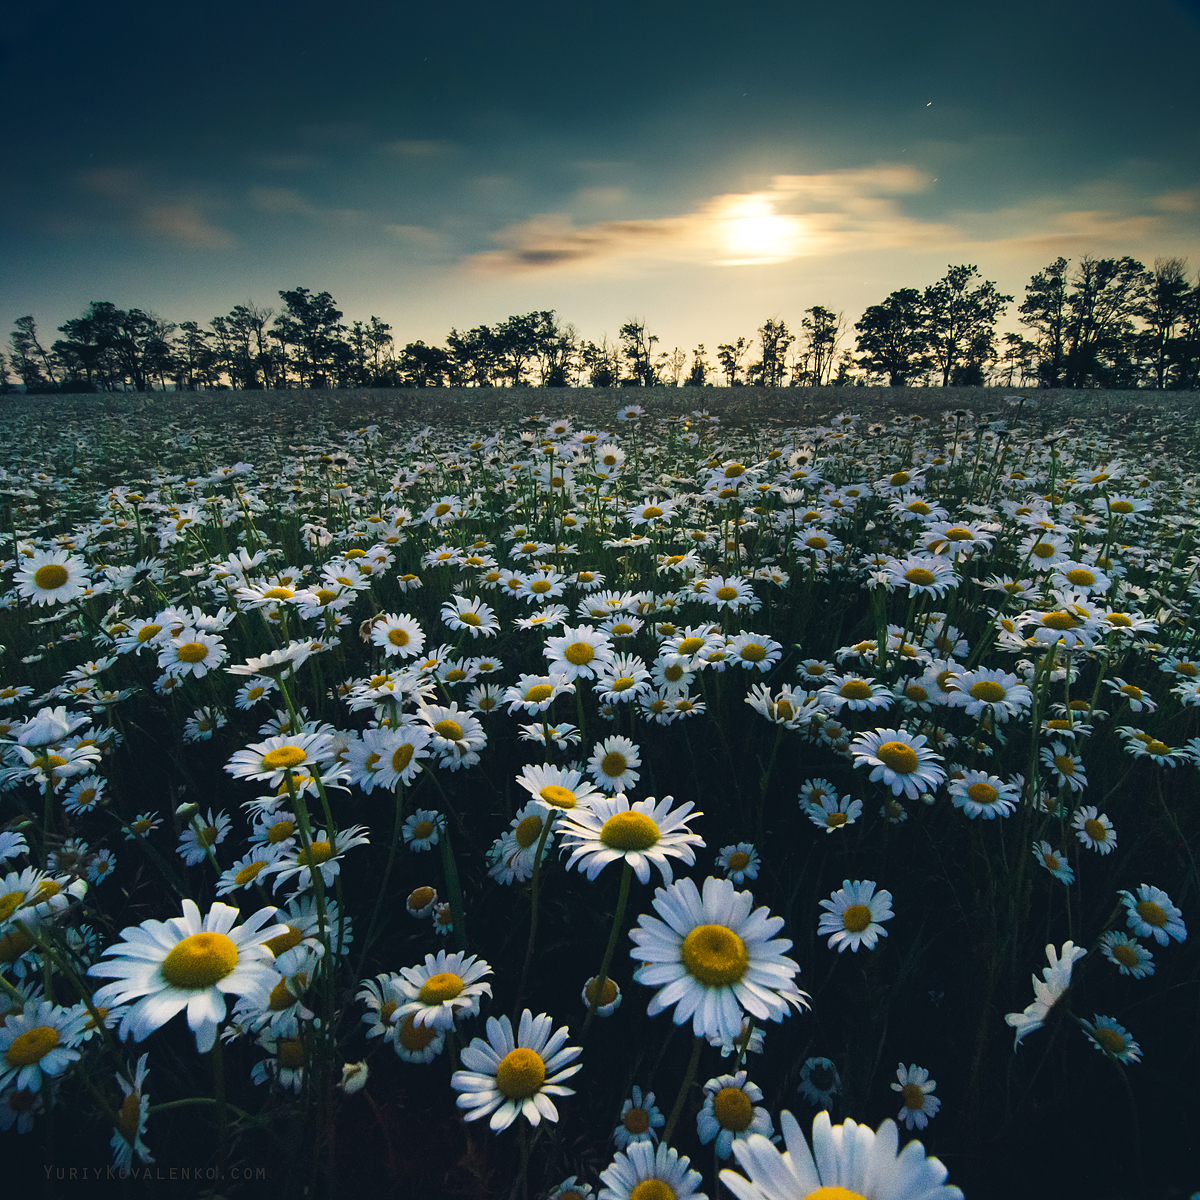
[450,1008,582,1133]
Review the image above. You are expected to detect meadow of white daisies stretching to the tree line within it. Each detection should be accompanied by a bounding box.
[0,389,1200,1200]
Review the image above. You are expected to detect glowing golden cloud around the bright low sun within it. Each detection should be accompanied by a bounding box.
[468,164,959,271]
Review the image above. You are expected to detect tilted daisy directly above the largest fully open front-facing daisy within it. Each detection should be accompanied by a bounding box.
[558,792,704,883]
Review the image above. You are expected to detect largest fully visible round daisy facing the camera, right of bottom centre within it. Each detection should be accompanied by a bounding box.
[629,877,808,1042]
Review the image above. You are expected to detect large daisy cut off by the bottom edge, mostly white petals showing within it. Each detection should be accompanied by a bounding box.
[721,1110,962,1200]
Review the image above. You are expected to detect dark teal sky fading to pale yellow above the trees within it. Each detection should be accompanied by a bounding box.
[0,0,1200,360]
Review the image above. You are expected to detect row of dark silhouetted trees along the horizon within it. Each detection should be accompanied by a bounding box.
[9,254,1200,392]
